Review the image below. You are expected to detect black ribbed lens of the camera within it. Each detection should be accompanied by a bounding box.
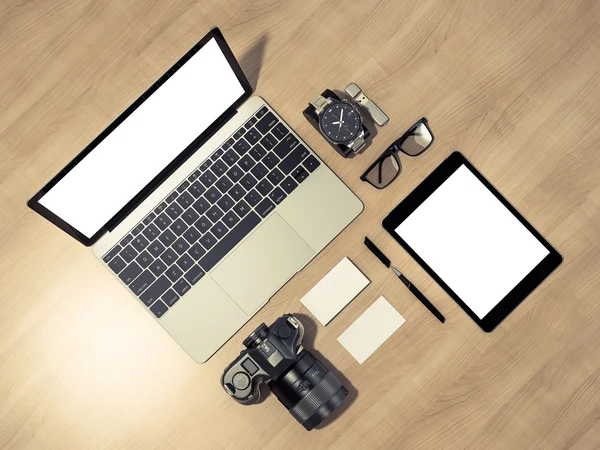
[269,350,348,431]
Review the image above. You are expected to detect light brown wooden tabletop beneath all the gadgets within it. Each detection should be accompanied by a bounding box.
[0,0,600,449]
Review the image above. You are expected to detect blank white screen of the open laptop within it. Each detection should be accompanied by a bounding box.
[38,37,245,239]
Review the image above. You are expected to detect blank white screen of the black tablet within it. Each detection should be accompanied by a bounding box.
[395,165,550,319]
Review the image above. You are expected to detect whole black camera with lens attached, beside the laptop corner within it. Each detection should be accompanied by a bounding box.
[221,314,348,431]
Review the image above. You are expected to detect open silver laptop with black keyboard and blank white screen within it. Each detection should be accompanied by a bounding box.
[28,28,363,362]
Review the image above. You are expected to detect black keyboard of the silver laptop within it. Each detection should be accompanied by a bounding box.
[102,106,320,317]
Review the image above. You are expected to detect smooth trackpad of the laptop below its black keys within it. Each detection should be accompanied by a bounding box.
[211,213,314,315]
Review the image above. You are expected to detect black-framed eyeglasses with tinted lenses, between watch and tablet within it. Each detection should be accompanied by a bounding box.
[360,117,434,189]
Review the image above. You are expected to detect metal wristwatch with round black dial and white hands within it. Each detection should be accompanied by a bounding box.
[310,95,366,154]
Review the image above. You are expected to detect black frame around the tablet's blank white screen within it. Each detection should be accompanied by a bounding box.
[382,151,562,332]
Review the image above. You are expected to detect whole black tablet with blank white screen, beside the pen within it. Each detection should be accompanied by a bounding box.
[383,152,562,332]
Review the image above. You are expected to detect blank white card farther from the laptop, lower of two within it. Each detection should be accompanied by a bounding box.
[338,296,405,364]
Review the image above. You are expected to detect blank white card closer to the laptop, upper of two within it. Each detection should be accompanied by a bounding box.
[300,257,371,326]
